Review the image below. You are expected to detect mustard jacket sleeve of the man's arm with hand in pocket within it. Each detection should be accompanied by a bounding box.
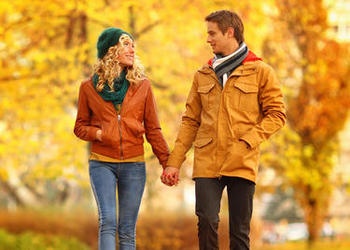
[240,64,286,148]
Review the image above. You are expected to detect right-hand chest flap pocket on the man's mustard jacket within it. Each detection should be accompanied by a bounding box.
[228,80,260,113]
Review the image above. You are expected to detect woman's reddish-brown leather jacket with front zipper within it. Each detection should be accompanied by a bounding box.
[74,78,169,167]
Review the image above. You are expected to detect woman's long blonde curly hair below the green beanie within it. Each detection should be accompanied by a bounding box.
[93,34,145,92]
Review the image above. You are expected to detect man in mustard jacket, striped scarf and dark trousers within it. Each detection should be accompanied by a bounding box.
[161,10,286,250]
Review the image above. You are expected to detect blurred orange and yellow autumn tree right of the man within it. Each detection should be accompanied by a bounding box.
[264,0,350,243]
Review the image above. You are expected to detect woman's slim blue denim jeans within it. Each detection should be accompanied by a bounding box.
[89,160,146,250]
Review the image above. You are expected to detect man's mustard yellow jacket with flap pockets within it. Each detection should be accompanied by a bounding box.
[167,52,286,182]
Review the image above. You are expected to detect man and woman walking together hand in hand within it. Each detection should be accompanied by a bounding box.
[74,10,286,250]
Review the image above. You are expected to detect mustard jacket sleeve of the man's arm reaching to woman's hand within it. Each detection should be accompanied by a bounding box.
[168,76,202,168]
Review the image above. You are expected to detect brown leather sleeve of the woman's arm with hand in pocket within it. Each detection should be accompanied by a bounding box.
[74,81,98,141]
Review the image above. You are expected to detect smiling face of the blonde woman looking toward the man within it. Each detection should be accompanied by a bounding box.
[117,35,135,67]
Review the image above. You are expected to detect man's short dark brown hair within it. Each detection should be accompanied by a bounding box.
[205,10,244,44]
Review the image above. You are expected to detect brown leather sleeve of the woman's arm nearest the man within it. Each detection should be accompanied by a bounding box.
[144,83,169,168]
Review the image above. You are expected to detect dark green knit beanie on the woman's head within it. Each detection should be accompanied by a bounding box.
[97,28,133,59]
